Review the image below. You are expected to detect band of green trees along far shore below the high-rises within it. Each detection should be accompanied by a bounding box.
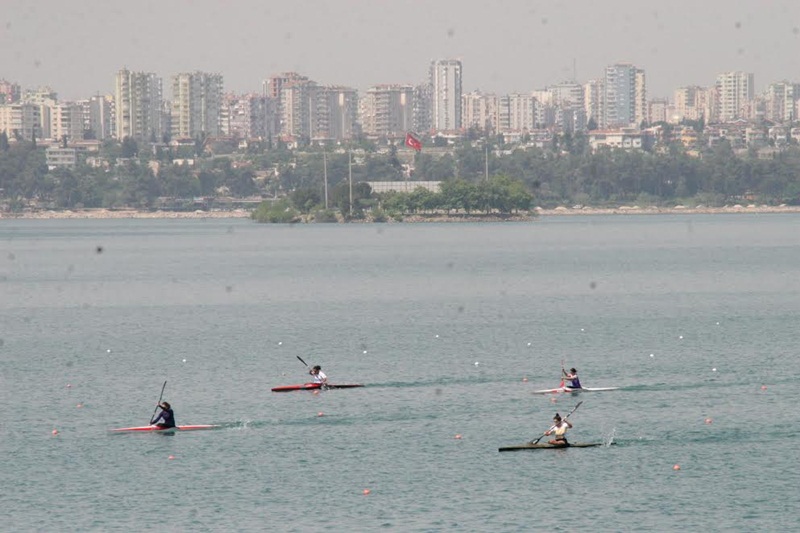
[0,134,800,216]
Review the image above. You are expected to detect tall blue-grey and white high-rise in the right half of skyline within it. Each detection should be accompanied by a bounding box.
[603,63,647,128]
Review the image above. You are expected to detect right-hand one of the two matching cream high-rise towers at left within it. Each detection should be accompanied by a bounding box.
[170,72,222,139]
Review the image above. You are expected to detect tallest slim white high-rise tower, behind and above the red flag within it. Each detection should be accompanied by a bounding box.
[430,59,462,131]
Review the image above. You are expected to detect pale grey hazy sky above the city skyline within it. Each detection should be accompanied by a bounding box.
[0,0,800,99]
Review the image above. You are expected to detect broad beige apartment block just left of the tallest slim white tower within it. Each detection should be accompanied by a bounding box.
[360,85,414,137]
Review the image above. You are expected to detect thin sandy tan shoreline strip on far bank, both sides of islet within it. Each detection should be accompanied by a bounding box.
[0,204,800,223]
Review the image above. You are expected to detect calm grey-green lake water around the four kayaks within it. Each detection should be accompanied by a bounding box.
[0,215,800,531]
